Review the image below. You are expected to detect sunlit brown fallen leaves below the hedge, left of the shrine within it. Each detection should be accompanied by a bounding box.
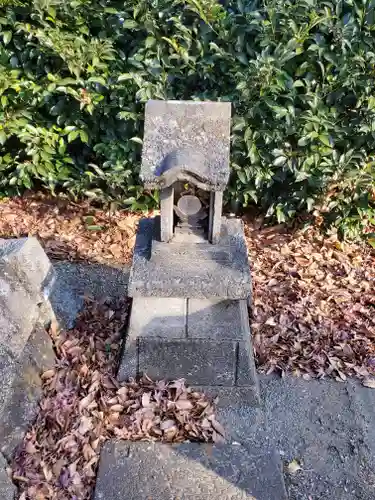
[0,194,142,264]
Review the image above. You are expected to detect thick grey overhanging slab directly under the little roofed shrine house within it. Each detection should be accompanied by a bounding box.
[129,218,251,300]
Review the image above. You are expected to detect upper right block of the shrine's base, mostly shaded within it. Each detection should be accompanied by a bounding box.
[188,299,244,340]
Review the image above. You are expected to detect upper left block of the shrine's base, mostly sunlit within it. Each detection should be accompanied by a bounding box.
[127,297,187,342]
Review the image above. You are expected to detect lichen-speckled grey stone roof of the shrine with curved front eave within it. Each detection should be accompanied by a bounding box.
[141,101,231,191]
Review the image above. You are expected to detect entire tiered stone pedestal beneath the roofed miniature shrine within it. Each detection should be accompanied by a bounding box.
[118,219,258,402]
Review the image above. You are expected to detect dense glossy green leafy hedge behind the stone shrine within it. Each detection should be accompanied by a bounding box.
[0,0,375,236]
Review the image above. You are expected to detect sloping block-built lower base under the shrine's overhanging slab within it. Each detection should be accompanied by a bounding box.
[118,297,257,398]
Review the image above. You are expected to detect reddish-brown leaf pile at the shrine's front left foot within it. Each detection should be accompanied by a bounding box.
[13,300,224,500]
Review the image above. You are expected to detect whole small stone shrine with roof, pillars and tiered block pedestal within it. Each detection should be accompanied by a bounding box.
[119,101,256,397]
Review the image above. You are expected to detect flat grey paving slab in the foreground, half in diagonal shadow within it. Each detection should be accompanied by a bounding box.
[94,441,287,500]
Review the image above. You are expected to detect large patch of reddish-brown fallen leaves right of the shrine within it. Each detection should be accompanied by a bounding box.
[246,221,375,384]
